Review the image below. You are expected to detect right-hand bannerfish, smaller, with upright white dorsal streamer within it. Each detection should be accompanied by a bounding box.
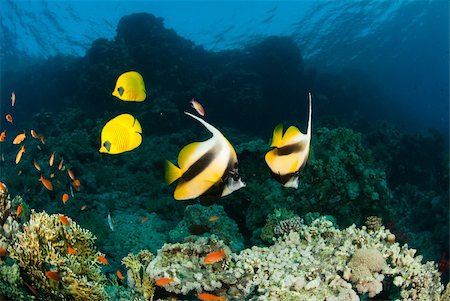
[265,93,312,188]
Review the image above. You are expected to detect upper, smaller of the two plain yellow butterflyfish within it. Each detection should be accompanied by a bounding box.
[112,71,147,102]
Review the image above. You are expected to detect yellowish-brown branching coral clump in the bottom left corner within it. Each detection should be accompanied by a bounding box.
[9,211,107,301]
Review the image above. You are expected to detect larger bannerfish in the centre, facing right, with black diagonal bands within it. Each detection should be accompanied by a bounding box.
[165,112,245,200]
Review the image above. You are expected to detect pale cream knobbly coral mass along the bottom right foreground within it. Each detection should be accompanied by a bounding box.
[147,217,443,301]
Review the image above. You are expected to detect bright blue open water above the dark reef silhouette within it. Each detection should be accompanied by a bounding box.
[0,0,449,136]
